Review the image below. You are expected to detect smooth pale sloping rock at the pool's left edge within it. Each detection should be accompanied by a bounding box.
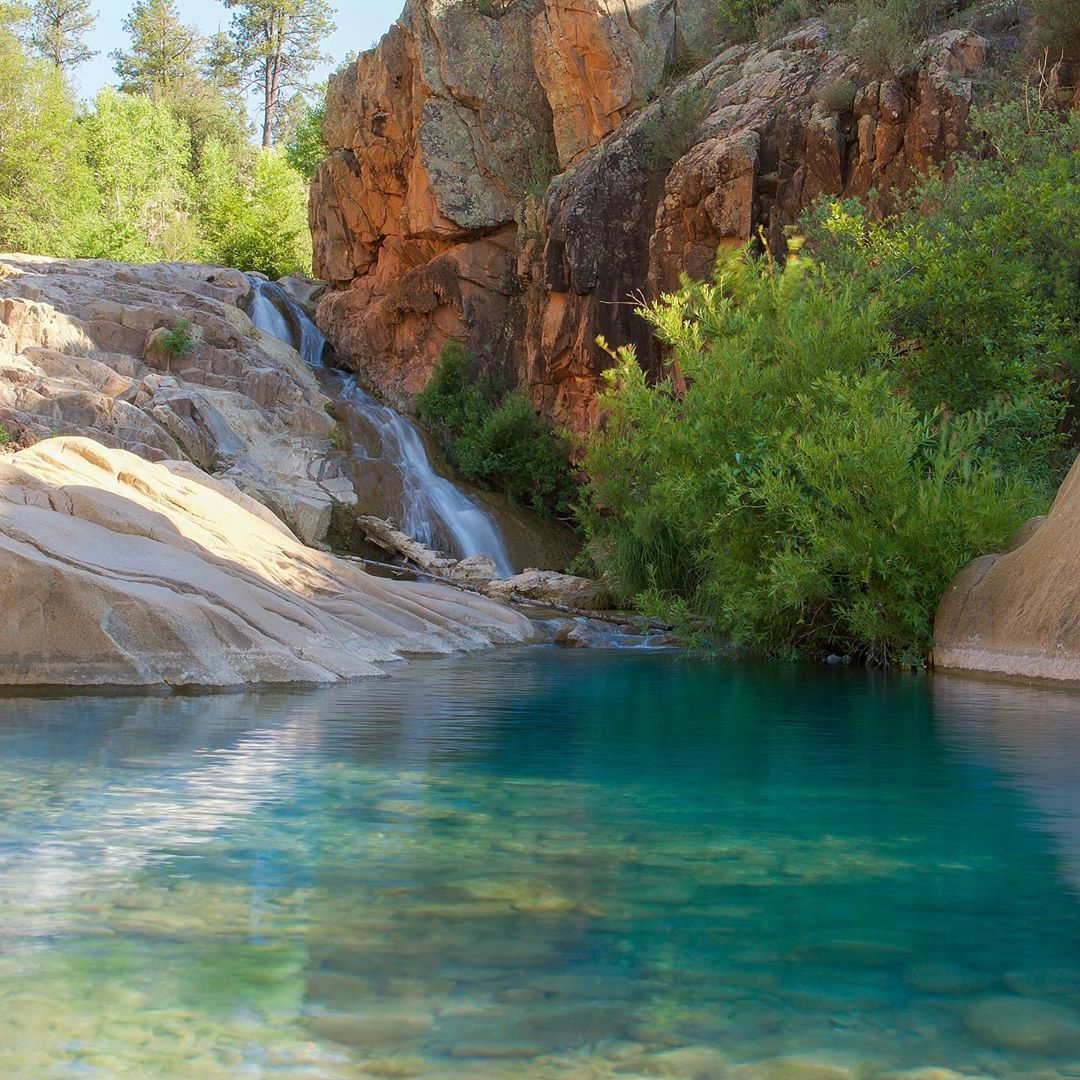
[0,437,531,686]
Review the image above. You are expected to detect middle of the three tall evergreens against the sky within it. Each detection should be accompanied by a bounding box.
[110,0,205,94]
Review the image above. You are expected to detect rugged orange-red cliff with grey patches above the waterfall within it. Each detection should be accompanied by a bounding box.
[311,0,988,431]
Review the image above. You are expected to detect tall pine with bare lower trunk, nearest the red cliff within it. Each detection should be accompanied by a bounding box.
[225,0,334,146]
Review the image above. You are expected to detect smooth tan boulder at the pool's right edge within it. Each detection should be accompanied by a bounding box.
[934,460,1080,680]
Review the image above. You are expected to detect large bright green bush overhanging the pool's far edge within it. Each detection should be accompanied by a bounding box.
[582,253,1049,663]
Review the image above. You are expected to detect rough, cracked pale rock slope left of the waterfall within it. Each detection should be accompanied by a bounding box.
[0,255,355,542]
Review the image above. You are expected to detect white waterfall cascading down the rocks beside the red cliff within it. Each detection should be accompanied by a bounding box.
[251,278,514,577]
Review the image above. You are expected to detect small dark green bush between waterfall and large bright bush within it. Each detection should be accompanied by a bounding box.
[417,341,573,514]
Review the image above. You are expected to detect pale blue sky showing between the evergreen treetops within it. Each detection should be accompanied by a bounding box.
[75,0,404,98]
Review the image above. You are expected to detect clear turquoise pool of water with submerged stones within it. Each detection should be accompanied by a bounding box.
[0,648,1080,1080]
